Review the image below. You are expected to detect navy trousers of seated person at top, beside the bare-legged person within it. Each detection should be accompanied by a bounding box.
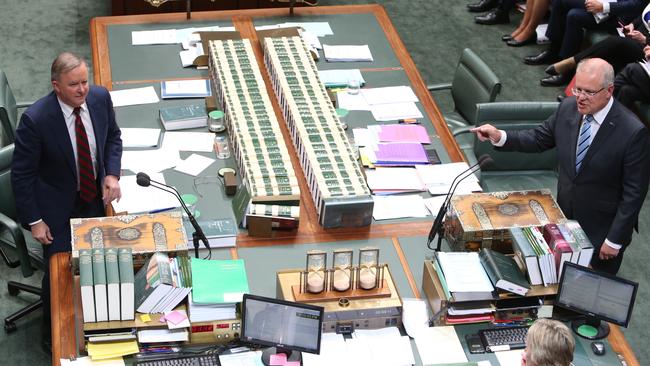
[546,0,616,59]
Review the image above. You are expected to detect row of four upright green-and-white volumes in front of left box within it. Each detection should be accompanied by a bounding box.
[79,248,134,323]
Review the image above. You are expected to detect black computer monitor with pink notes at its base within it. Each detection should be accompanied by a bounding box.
[241,294,323,365]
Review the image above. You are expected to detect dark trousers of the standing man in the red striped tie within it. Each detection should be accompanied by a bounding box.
[41,190,106,340]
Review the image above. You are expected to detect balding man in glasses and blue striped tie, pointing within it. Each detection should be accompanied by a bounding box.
[472,59,650,273]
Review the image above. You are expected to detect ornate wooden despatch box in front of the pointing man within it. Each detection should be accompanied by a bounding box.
[444,189,566,252]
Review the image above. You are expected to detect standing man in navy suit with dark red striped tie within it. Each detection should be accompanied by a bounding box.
[11,52,122,343]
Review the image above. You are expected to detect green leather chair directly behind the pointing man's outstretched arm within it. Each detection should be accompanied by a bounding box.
[454,102,559,196]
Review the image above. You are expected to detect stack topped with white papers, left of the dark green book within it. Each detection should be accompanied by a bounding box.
[433,252,499,324]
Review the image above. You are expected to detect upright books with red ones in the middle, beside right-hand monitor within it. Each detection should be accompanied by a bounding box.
[510,220,594,286]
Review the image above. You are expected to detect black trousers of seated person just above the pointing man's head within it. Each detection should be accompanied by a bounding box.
[574,36,644,73]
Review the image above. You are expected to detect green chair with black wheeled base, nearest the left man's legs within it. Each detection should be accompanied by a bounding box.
[0,144,44,333]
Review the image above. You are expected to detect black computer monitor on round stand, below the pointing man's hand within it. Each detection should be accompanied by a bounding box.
[555,262,639,339]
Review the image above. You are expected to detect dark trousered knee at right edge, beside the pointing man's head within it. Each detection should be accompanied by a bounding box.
[614,62,650,109]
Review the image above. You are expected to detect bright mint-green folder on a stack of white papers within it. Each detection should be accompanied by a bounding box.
[189,258,249,323]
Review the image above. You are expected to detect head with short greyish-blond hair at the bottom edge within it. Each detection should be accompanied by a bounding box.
[521,319,576,366]
